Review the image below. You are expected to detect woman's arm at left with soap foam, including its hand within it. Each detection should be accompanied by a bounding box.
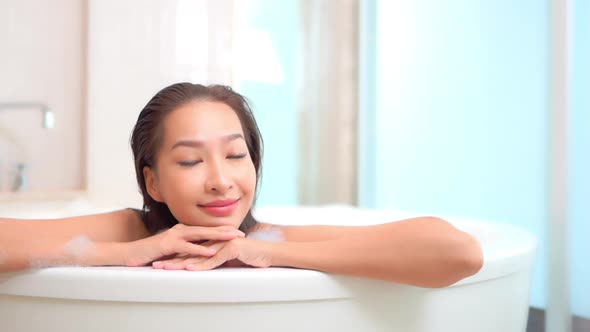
[0,209,244,272]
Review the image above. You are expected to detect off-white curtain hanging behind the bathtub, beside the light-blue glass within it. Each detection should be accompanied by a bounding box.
[299,0,359,204]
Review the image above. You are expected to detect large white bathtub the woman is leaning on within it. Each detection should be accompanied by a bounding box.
[0,200,536,332]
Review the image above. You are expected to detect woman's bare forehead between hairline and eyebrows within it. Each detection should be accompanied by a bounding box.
[164,101,244,144]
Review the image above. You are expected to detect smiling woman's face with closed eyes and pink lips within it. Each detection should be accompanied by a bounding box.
[144,101,256,228]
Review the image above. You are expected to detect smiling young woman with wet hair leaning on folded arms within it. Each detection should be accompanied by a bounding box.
[0,83,483,287]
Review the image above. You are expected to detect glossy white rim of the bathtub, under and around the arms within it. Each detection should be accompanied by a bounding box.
[0,206,537,303]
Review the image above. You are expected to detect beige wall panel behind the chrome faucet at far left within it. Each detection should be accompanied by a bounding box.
[0,0,86,192]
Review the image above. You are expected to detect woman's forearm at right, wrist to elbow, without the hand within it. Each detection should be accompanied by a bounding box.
[271,218,482,287]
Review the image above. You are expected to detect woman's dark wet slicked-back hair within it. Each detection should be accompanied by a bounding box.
[131,83,262,234]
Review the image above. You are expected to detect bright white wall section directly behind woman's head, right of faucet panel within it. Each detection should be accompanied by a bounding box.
[87,0,233,207]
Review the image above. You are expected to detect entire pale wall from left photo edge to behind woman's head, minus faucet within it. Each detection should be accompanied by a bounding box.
[0,0,234,207]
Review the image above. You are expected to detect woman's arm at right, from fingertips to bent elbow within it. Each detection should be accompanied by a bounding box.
[140,217,483,288]
